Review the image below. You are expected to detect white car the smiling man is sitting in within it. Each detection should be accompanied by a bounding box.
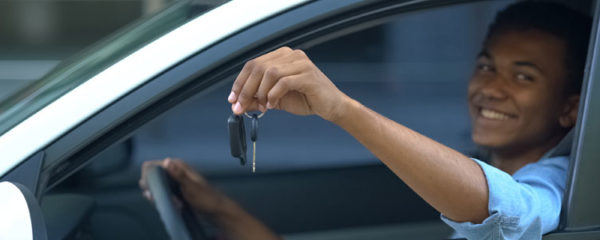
[0,0,600,239]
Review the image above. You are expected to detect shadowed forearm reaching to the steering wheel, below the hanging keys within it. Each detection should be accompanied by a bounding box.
[211,199,281,240]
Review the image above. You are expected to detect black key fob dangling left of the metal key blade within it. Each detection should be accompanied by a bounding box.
[227,114,247,165]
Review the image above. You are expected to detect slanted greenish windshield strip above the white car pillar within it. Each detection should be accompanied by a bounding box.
[0,0,227,134]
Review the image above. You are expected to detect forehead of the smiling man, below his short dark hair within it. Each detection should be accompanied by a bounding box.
[484,30,566,71]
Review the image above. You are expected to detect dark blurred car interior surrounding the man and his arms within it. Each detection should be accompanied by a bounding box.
[16,1,591,239]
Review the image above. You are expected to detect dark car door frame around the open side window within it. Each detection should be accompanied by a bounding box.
[3,0,600,239]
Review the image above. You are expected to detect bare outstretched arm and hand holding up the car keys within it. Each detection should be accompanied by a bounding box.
[228,47,488,223]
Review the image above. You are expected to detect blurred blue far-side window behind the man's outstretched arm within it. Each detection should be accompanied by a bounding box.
[133,2,509,173]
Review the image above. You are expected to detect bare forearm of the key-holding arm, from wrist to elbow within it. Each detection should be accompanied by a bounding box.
[334,99,488,222]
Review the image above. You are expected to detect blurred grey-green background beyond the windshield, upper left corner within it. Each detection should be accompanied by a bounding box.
[0,0,175,101]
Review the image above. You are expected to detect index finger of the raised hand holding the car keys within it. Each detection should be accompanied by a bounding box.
[227,47,292,103]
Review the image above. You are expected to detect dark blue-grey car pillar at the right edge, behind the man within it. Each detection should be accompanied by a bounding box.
[561,2,600,231]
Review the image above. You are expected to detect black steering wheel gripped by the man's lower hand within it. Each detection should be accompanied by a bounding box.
[146,166,208,240]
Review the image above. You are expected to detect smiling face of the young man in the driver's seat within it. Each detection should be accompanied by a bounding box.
[468,30,576,155]
